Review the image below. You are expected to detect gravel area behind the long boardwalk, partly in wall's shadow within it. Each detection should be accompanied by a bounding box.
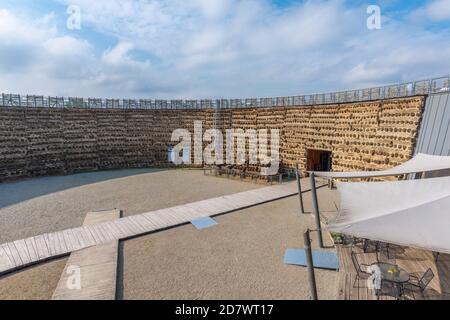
[0,169,261,243]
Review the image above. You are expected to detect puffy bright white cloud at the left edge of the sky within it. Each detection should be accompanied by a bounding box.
[0,10,95,81]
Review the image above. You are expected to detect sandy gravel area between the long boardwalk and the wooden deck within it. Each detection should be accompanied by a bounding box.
[119,197,337,299]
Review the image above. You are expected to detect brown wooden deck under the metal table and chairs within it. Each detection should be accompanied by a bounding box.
[337,246,450,300]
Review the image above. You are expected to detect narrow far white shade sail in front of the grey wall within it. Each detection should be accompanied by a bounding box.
[314,153,450,179]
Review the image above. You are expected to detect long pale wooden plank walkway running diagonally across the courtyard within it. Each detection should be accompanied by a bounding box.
[0,179,309,275]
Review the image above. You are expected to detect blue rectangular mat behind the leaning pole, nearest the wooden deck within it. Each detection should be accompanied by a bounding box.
[284,249,339,270]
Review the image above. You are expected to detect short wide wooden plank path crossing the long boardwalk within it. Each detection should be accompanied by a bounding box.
[52,209,120,300]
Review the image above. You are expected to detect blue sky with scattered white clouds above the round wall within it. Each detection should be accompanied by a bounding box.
[0,0,450,99]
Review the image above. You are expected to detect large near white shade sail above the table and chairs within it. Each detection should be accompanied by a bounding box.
[329,177,450,253]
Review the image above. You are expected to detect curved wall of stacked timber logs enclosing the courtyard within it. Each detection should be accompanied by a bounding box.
[0,96,425,181]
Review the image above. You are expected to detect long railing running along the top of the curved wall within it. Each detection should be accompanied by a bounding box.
[0,75,450,109]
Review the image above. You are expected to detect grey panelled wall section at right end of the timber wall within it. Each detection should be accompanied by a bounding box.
[415,92,450,156]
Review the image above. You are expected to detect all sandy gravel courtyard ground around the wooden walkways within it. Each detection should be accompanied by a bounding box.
[0,169,337,299]
